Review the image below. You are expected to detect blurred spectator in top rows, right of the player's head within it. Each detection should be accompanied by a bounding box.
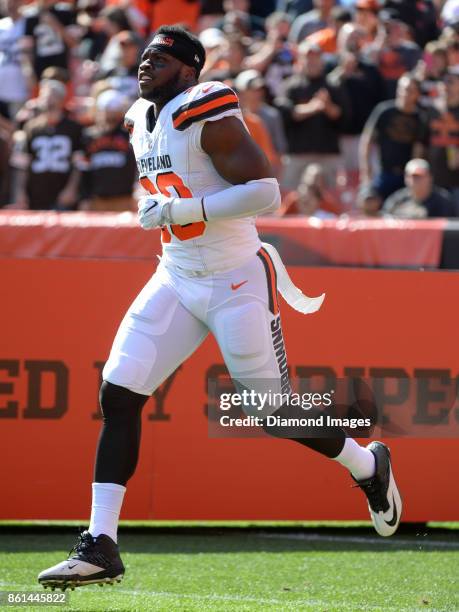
[246,12,295,99]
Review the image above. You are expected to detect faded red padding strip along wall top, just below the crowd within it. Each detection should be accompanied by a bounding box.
[0,211,447,268]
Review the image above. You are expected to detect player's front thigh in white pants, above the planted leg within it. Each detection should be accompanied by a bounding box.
[103,275,208,395]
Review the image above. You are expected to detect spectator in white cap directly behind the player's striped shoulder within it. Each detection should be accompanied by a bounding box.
[234,70,287,169]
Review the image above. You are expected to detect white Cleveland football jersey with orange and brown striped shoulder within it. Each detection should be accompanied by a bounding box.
[126,81,261,272]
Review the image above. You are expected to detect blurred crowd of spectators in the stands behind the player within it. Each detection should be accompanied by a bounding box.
[0,0,459,219]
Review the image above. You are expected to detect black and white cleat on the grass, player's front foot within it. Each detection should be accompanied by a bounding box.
[38,531,124,591]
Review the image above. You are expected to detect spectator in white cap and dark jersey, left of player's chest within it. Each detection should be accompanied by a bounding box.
[80,89,136,211]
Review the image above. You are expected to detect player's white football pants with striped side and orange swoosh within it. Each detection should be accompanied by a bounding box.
[103,248,290,414]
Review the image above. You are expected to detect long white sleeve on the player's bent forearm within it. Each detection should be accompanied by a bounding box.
[171,178,281,225]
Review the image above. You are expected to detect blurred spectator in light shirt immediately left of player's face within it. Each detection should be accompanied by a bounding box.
[98,30,141,102]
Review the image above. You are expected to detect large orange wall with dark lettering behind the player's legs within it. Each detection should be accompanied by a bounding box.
[0,258,459,521]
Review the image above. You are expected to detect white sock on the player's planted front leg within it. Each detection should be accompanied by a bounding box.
[88,482,126,542]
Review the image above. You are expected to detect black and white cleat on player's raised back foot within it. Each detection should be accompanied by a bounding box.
[354,442,402,537]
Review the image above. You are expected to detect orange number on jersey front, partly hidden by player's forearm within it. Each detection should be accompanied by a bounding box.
[140,172,206,242]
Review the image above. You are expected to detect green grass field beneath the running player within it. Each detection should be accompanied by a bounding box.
[0,524,459,612]
